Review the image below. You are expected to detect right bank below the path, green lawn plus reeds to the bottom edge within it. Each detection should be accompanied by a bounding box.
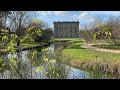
[58,40,120,79]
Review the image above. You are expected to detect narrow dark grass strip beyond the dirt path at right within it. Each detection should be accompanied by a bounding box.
[92,44,120,50]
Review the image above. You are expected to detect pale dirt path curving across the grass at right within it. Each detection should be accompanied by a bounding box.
[81,44,120,53]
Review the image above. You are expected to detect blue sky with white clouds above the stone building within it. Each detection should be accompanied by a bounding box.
[38,11,120,28]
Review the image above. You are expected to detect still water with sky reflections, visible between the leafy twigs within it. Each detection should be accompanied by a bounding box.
[0,43,90,79]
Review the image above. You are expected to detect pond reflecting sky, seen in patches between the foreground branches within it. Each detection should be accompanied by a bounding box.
[0,42,90,79]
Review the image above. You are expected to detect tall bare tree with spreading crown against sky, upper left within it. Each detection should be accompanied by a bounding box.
[7,11,36,46]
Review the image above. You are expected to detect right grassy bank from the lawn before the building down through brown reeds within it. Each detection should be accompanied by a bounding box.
[53,39,120,77]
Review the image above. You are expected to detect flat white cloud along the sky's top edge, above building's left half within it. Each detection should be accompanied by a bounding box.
[38,11,68,16]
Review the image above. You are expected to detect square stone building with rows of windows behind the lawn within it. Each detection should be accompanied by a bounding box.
[53,21,80,38]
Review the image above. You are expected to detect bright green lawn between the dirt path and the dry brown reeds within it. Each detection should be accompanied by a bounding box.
[63,41,120,61]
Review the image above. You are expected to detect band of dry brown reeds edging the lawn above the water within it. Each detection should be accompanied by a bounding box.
[69,61,120,78]
